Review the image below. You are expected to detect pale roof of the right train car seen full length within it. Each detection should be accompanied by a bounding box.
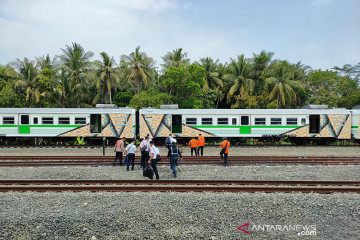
[140,108,350,115]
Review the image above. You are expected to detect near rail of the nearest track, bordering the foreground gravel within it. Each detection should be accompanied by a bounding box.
[0,185,360,193]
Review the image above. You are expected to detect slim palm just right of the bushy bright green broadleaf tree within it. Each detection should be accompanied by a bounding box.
[198,57,224,91]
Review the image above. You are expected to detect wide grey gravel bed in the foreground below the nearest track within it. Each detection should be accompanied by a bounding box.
[0,192,360,239]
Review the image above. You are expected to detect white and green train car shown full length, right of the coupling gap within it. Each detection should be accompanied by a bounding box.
[139,106,358,143]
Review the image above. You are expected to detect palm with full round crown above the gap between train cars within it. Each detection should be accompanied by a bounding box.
[120,47,156,93]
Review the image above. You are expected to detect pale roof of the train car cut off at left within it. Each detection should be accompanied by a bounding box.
[0,108,135,114]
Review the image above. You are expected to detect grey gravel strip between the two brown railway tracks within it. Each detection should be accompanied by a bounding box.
[0,164,360,181]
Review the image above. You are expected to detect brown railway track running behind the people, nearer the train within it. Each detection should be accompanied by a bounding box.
[0,156,360,167]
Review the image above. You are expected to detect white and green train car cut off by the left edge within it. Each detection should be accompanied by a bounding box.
[0,107,136,138]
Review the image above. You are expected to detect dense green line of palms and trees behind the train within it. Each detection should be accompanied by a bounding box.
[0,43,360,109]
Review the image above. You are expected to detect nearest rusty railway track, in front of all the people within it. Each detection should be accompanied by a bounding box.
[0,180,360,193]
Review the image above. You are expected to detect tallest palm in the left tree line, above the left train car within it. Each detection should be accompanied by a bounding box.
[59,43,94,107]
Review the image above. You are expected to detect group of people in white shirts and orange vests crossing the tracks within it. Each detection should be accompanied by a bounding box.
[113,134,230,179]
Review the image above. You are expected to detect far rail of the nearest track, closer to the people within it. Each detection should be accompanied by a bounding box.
[0,179,360,186]
